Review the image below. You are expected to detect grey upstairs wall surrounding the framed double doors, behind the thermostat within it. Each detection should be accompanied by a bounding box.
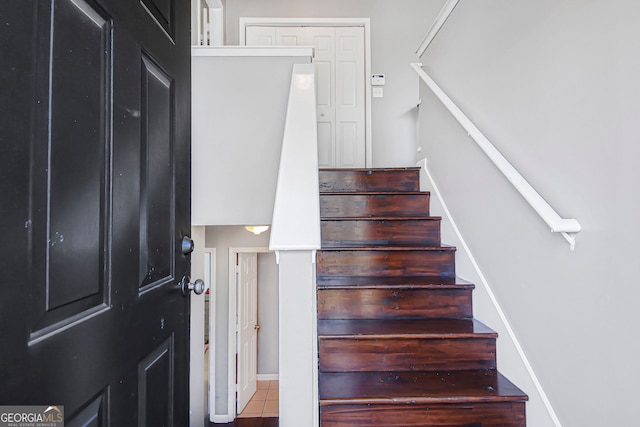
[225,0,442,167]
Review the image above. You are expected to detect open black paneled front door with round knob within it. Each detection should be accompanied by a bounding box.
[0,0,190,427]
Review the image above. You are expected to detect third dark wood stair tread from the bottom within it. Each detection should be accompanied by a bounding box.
[317,276,475,289]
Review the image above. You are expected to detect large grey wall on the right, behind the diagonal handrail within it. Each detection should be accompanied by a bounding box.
[419,0,640,427]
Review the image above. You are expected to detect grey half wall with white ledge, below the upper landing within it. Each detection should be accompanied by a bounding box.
[192,51,311,225]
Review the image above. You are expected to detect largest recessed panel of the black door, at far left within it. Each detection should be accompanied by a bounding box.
[28,0,111,342]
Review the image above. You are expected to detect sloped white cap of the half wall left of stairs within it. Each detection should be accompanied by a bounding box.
[269,64,320,251]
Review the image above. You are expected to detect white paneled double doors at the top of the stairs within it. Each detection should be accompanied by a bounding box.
[245,25,366,168]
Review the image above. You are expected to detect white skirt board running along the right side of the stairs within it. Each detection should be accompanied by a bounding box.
[416,158,562,427]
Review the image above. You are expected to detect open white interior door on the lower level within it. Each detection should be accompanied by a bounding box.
[236,252,259,414]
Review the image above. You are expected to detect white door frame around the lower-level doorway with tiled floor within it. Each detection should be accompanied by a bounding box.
[227,246,273,422]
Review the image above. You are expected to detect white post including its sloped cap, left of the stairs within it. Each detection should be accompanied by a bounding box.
[269,64,321,427]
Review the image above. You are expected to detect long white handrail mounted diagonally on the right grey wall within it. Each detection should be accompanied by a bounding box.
[411,63,582,250]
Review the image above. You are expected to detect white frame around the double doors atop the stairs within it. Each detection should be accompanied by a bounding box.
[238,17,373,168]
